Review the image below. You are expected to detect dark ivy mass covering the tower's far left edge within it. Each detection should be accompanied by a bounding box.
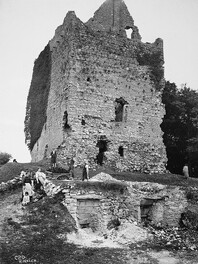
[25,44,51,150]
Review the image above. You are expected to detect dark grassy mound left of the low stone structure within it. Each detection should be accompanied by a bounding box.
[0,194,126,264]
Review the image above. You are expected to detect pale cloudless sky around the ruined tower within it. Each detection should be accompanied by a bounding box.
[0,0,198,162]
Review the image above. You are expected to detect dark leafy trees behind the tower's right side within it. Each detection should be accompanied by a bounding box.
[161,81,198,174]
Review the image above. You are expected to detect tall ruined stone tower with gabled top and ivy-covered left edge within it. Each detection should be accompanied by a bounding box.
[25,0,166,173]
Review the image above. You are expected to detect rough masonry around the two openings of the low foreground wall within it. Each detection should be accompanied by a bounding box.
[44,180,189,231]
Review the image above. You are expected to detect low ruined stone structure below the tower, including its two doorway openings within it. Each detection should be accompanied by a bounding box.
[44,173,188,233]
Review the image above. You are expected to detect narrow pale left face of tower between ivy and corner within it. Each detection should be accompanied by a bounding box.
[31,12,86,161]
